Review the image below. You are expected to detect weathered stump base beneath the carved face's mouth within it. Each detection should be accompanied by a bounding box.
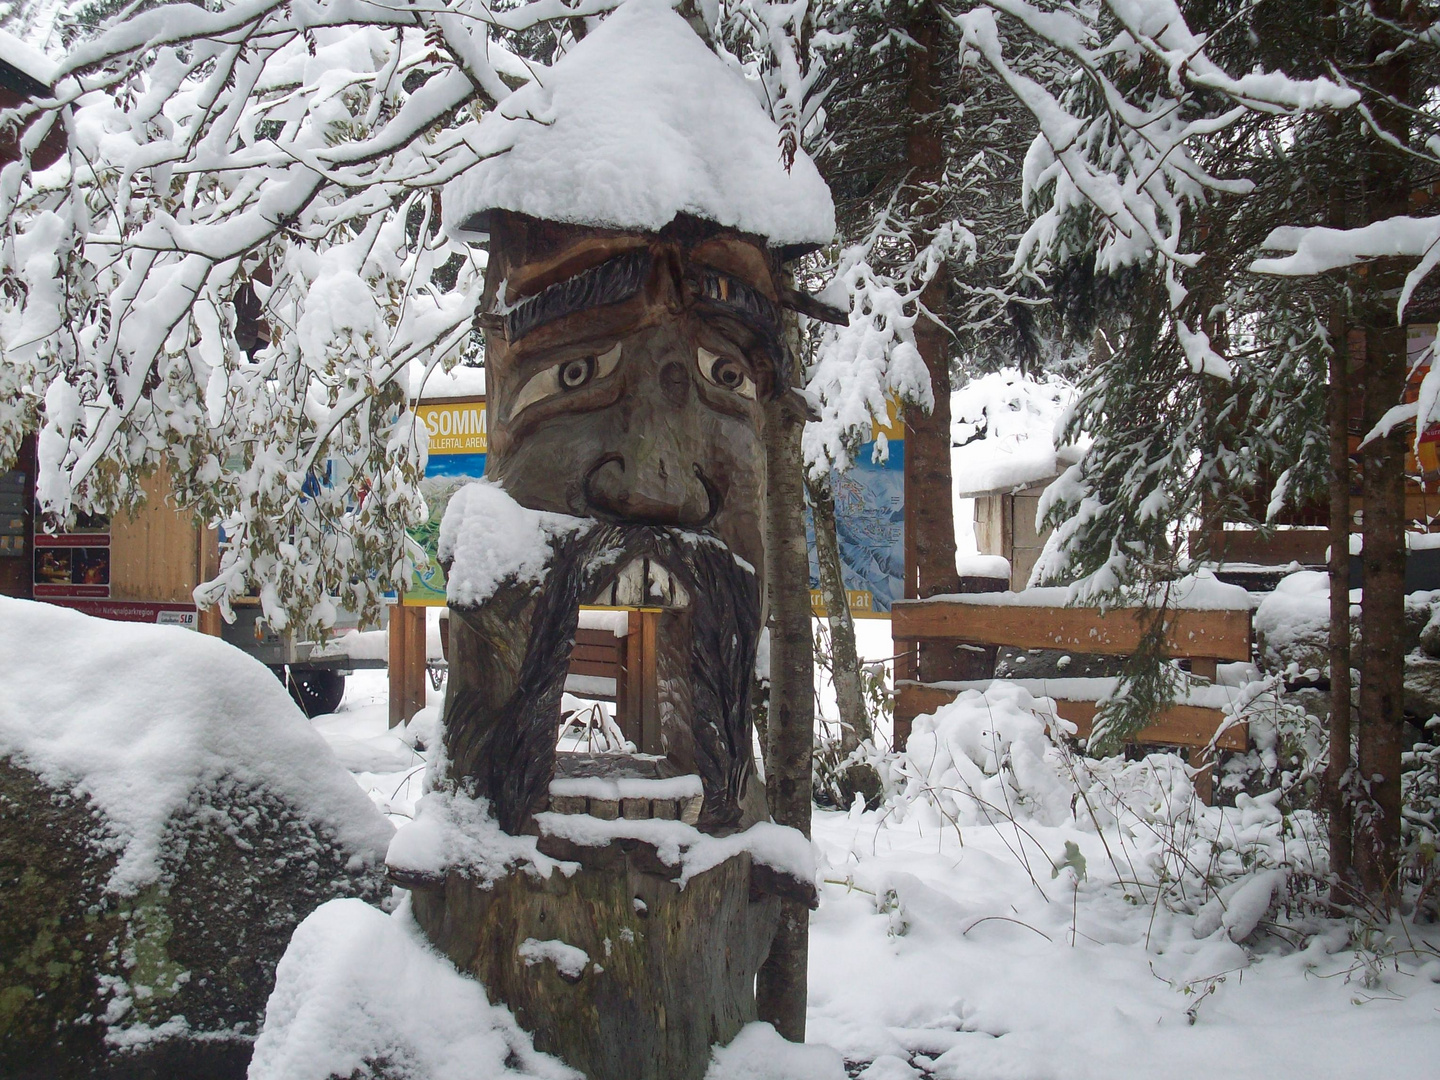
[408,832,783,1080]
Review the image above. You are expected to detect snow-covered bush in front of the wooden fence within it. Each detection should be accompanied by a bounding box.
[869,683,1325,940]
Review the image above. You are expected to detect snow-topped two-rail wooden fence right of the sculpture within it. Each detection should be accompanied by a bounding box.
[890,589,1250,804]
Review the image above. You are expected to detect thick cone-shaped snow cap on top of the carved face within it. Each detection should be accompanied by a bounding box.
[445,0,835,245]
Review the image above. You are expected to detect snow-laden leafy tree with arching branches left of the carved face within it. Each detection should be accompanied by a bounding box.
[0,0,613,626]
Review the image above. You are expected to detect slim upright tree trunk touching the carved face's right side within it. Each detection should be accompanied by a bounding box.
[755,399,815,1043]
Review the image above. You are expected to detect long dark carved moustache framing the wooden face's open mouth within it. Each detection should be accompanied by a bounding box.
[445,523,760,834]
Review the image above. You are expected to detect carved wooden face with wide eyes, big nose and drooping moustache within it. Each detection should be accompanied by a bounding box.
[445,213,789,832]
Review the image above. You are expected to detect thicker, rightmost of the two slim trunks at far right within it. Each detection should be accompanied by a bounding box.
[1355,0,1411,910]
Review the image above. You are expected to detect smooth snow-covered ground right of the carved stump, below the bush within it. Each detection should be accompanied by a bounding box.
[808,812,1440,1080]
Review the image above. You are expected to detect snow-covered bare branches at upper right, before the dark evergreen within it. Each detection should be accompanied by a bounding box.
[953,0,1359,288]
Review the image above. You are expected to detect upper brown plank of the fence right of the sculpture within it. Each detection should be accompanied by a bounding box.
[890,599,1250,661]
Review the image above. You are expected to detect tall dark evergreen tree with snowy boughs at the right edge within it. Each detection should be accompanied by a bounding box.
[960,0,1440,904]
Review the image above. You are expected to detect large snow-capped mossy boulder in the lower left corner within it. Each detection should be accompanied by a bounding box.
[0,598,393,1077]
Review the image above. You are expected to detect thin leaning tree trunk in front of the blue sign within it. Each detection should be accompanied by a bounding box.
[805,477,881,806]
